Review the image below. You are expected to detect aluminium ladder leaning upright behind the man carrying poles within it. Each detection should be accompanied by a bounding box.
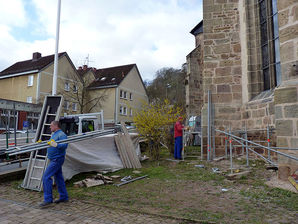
[22,96,63,191]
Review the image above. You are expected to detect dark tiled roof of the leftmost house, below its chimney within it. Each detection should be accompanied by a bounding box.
[0,52,67,77]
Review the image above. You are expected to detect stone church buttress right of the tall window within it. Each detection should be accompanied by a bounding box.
[274,0,298,179]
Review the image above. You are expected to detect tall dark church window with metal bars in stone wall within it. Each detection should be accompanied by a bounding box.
[259,0,281,90]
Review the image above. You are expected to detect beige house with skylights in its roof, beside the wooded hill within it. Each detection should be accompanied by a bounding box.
[86,64,148,123]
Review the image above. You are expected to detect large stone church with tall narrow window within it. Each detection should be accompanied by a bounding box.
[185,0,298,178]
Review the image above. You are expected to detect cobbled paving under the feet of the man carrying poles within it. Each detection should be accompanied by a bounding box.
[0,184,181,224]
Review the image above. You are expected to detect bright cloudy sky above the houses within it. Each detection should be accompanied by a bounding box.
[0,0,202,80]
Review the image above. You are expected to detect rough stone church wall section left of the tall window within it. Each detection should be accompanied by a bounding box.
[202,0,242,158]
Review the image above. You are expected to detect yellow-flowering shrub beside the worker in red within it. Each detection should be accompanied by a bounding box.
[133,100,182,160]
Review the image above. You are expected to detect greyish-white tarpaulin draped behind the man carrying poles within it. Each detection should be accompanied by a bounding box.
[62,134,140,180]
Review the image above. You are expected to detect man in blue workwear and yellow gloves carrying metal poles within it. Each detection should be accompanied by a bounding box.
[40,121,68,207]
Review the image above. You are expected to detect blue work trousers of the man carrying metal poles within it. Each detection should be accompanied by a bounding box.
[43,157,68,202]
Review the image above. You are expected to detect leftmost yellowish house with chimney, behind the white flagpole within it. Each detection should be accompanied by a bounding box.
[0,52,81,113]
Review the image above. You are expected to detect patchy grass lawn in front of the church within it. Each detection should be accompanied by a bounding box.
[57,147,298,223]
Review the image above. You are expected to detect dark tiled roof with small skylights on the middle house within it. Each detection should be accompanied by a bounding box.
[88,64,136,89]
